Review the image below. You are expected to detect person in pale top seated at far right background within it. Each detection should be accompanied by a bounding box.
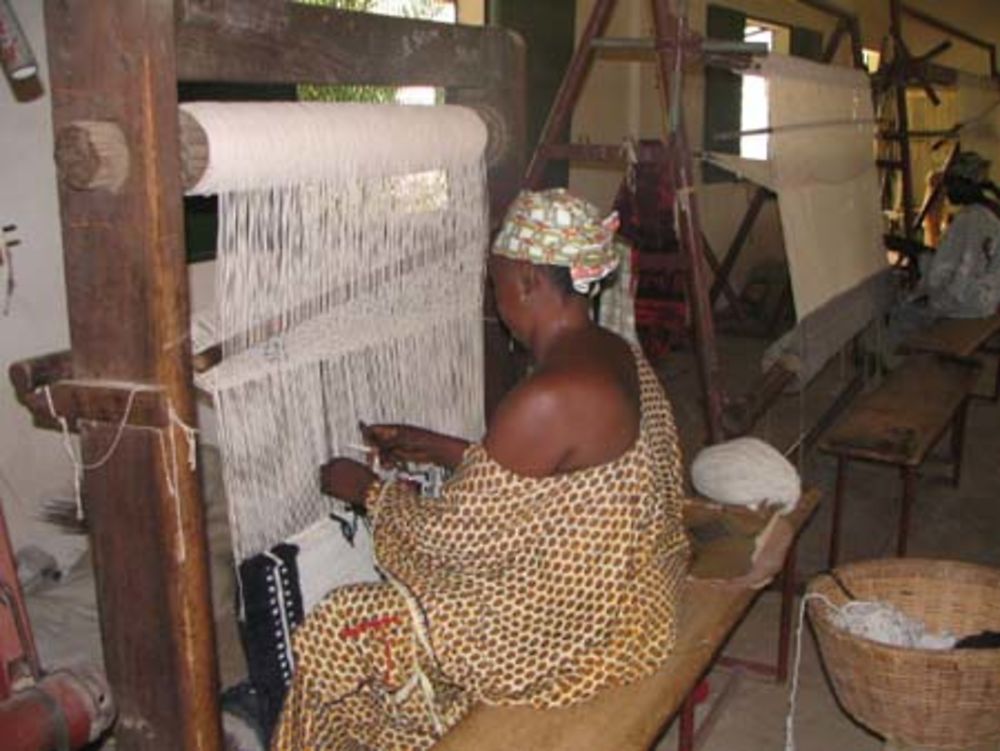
[887,151,1000,353]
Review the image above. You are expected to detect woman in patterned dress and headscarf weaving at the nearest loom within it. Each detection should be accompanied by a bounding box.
[272,190,688,751]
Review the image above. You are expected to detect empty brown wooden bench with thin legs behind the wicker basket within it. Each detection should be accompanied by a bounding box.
[819,354,980,568]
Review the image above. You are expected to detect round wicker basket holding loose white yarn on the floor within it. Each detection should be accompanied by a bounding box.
[809,559,1000,749]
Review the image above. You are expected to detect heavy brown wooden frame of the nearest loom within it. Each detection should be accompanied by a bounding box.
[12,0,524,751]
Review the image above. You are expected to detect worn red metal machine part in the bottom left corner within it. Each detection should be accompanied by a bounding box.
[0,496,115,751]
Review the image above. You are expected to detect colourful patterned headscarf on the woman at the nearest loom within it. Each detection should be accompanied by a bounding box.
[493,188,623,294]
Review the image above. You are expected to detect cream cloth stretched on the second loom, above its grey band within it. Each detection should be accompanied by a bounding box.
[709,55,887,320]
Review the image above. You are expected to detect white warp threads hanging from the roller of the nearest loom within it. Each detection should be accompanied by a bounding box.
[184,103,488,559]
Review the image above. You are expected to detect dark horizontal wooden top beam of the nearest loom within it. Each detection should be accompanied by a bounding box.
[177,3,520,88]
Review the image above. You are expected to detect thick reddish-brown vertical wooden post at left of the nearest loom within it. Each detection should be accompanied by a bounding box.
[45,0,221,751]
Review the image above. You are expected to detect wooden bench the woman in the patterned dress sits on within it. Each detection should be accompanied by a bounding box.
[434,491,819,751]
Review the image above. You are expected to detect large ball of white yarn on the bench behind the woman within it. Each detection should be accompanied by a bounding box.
[691,438,802,512]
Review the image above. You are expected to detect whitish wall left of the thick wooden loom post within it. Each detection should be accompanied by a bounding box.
[0,0,84,564]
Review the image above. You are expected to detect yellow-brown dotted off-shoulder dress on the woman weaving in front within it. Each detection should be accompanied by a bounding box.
[272,354,688,751]
